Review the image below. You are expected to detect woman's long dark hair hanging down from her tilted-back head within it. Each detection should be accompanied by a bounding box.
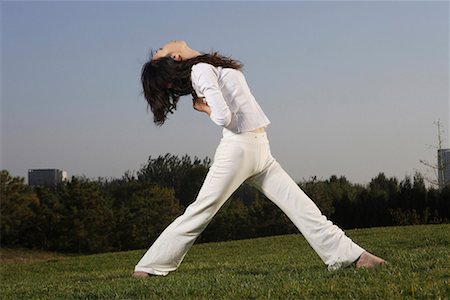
[141,52,243,126]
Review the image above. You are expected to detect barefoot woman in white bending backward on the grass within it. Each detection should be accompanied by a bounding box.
[133,41,384,277]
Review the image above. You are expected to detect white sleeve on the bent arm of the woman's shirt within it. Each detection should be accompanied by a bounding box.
[191,63,233,127]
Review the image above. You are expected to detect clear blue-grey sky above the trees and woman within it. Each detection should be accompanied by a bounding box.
[0,1,450,184]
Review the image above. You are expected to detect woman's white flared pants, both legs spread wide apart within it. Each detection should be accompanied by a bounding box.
[135,132,364,275]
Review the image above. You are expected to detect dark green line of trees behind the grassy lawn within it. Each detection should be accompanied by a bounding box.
[0,154,450,253]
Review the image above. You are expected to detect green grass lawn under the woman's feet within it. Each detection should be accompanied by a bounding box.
[0,225,450,299]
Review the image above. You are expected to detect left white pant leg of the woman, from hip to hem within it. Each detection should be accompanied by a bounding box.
[135,140,257,275]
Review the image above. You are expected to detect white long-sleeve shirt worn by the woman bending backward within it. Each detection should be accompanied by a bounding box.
[191,63,270,133]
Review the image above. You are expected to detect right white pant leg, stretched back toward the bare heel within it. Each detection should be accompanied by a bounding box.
[249,149,364,270]
